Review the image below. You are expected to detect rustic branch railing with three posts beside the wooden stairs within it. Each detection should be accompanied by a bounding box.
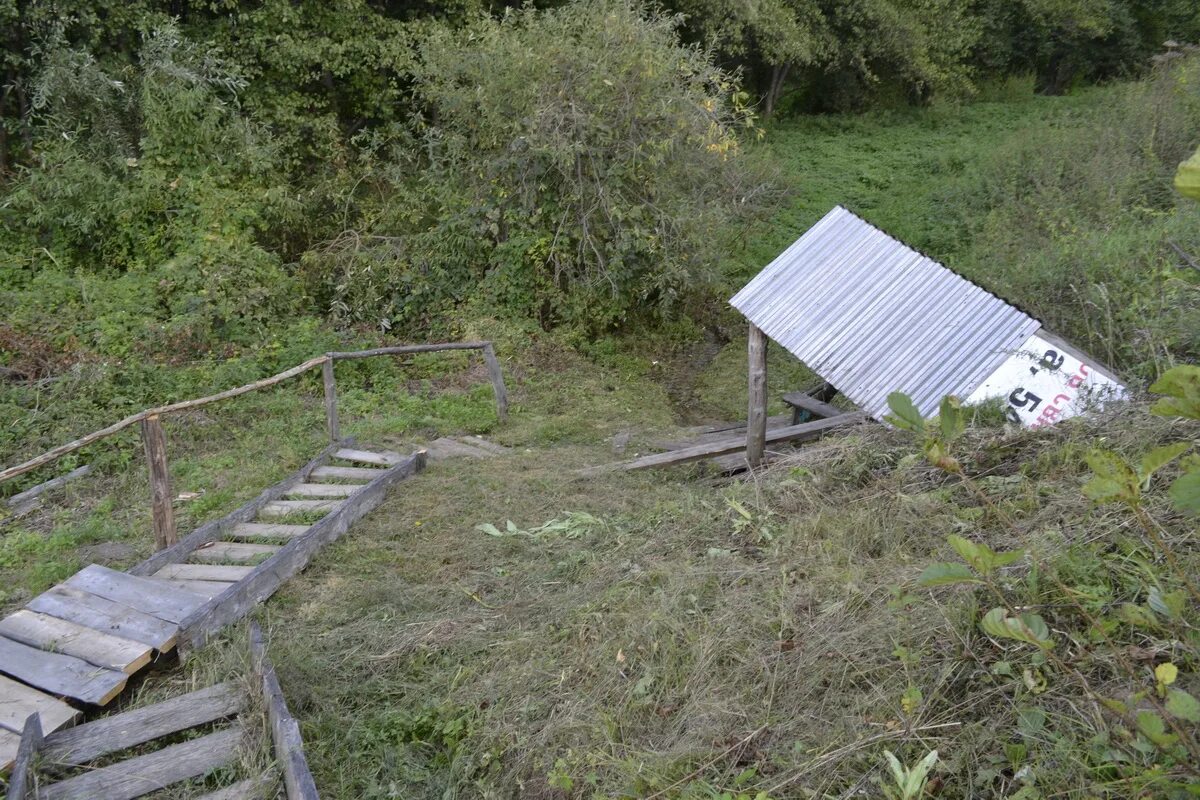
[0,342,509,549]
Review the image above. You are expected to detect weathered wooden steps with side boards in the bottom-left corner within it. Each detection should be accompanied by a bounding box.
[7,624,318,800]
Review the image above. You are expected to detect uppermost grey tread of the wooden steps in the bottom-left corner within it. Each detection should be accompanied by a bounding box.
[42,684,245,765]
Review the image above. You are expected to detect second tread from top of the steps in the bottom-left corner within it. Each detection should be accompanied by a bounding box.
[37,724,244,800]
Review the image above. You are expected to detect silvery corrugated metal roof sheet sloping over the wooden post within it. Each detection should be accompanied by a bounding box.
[730,206,1042,420]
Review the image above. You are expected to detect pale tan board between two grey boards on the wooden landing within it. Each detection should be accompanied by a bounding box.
[0,608,154,676]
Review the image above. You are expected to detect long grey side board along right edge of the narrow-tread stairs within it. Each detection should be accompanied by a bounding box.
[180,452,425,657]
